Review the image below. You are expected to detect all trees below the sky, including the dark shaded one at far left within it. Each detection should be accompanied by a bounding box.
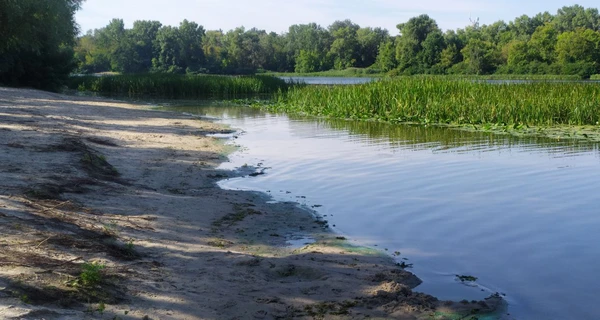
[0,0,600,90]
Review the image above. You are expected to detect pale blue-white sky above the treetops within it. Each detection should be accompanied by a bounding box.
[76,0,600,35]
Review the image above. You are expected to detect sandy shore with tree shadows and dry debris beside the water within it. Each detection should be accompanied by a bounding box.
[0,88,504,319]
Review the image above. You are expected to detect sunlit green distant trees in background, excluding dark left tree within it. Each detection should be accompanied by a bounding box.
[76,5,600,78]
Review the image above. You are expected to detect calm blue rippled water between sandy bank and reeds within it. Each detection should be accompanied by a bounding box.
[165,107,600,319]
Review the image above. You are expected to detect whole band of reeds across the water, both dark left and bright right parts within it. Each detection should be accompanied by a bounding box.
[69,75,600,140]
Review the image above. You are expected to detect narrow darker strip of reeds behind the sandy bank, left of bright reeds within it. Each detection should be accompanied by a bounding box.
[68,74,288,99]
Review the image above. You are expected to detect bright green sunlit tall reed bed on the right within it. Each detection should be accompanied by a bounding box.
[270,77,600,126]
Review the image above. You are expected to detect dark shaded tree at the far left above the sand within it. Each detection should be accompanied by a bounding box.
[0,0,83,90]
